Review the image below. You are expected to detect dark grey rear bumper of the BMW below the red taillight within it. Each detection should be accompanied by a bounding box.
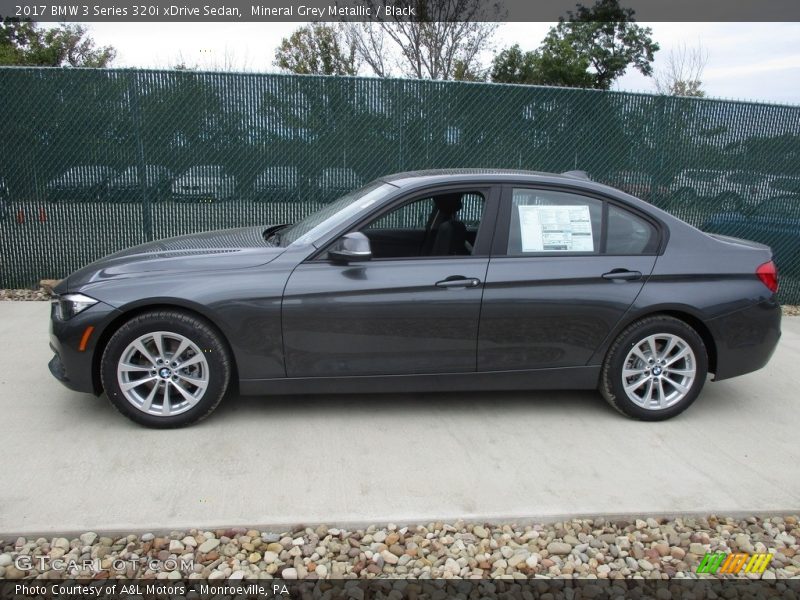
[707,297,781,381]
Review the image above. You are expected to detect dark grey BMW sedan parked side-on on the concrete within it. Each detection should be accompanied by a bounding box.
[50,170,781,427]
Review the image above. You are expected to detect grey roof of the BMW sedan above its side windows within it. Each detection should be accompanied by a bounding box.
[380,169,605,187]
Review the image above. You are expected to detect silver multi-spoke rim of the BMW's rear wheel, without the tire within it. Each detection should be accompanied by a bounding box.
[622,333,697,410]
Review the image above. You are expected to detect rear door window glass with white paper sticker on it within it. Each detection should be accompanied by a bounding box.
[506,189,603,256]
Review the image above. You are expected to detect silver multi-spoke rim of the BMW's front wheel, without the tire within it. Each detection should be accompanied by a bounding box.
[117,331,209,417]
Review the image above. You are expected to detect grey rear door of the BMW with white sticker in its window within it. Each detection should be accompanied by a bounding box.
[478,187,660,371]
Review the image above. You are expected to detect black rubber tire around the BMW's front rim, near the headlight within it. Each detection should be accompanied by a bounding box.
[100,310,232,429]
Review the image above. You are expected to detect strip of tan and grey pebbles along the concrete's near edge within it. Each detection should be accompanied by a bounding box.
[0,515,800,580]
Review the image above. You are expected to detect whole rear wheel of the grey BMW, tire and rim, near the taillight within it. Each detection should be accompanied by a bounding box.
[600,315,708,421]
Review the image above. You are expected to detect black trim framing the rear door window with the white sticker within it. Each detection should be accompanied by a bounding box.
[492,182,669,258]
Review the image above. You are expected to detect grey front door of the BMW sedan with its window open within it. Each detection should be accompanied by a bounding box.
[282,187,498,377]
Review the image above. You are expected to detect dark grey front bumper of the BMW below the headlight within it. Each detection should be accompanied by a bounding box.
[48,302,121,394]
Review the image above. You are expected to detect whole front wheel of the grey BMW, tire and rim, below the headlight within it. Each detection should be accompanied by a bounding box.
[101,310,231,428]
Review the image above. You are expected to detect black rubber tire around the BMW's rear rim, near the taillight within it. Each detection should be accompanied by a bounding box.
[600,315,708,421]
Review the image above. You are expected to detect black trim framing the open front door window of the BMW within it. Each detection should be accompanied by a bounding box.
[303,181,502,263]
